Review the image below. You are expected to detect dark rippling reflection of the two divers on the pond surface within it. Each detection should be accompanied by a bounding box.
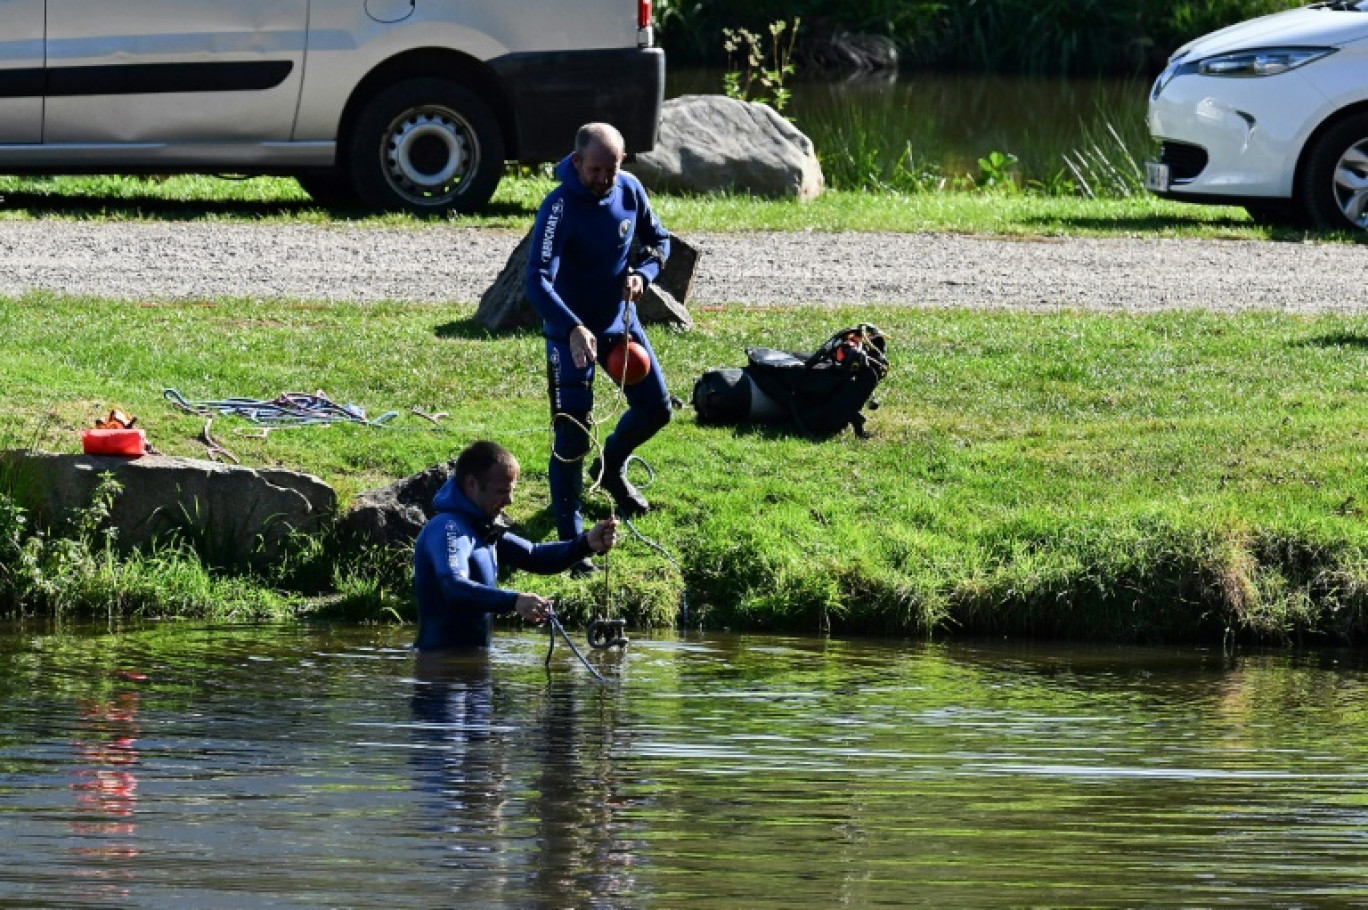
[410,653,636,907]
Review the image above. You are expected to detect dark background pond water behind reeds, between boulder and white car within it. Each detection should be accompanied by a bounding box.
[666,70,1150,189]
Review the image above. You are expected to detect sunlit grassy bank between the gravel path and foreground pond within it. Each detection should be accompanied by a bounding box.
[0,296,1368,640]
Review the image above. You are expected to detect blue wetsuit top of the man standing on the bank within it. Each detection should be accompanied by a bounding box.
[527,157,670,341]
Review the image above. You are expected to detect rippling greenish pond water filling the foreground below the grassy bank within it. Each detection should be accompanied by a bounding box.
[8,625,1368,910]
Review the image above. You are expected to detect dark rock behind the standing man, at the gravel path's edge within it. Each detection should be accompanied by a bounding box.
[475,233,698,331]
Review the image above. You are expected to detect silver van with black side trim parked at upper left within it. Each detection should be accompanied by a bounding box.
[0,0,665,213]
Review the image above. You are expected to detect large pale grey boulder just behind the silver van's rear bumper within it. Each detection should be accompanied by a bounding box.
[632,94,826,200]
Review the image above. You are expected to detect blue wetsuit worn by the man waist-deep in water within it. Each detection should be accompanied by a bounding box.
[413,478,590,650]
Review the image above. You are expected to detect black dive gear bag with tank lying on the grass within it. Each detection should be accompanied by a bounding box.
[692,323,888,439]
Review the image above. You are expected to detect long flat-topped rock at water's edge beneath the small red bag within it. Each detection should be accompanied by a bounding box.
[0,452,337,567]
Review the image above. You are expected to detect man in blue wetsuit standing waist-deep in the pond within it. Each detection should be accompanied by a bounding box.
[413,441,617,651]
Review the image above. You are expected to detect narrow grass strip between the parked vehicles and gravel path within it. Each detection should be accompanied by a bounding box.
[0,177,1313,239]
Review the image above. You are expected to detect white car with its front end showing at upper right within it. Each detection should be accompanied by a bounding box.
[1145,0,1368,230]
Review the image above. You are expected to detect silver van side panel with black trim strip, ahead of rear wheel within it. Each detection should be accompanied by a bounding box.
[46,0,309,145]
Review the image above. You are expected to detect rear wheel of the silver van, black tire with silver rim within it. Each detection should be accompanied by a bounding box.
[346,79,503,215]
